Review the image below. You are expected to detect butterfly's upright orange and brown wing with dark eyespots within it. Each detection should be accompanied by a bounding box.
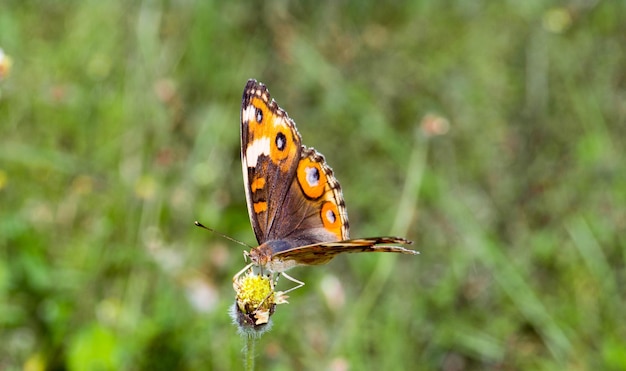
[241,80,349,246]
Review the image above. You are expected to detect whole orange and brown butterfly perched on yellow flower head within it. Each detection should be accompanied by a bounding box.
[235,79,418,291]
